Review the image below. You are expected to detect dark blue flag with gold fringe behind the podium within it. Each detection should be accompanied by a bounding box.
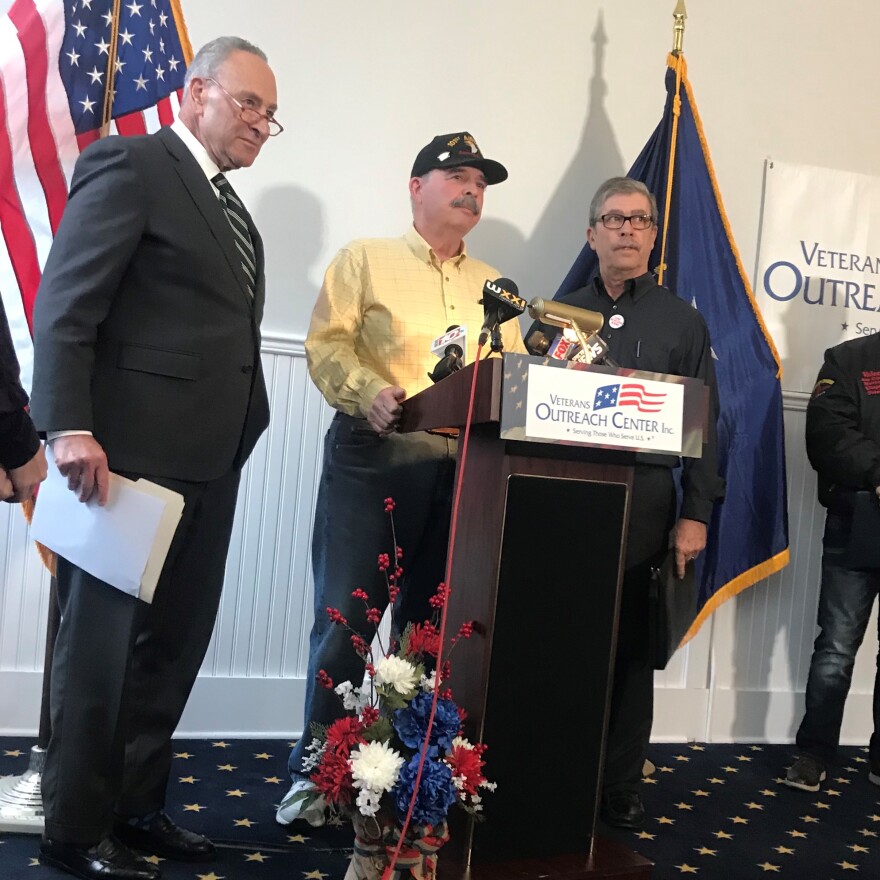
[556,55,789,641]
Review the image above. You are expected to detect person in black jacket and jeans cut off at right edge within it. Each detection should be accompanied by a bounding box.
[785,336,880,791]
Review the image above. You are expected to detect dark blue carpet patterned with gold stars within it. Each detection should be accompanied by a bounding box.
[0,737,880,880]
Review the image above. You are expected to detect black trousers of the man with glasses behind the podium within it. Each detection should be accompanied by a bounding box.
[603,465,676,794]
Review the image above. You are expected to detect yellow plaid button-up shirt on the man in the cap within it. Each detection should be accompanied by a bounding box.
[306,227,526,416]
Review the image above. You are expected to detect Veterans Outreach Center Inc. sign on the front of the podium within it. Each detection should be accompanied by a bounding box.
[501,354,705,458]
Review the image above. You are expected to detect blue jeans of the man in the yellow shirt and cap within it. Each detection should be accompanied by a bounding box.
[288,413,456,779]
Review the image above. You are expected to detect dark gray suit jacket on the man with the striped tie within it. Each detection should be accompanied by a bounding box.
[31,129,269,481]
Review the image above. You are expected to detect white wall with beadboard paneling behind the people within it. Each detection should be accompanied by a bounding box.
[0,0,880,740]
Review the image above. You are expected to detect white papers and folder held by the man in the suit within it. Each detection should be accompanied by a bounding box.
[31,459,183,602]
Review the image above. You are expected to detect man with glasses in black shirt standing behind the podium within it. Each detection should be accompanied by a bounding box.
[536,177,724,828]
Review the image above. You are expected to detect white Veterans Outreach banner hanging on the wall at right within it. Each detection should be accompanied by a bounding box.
[755,159,880,392]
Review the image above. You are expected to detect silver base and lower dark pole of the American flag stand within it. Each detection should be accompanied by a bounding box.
[0,577,61,834]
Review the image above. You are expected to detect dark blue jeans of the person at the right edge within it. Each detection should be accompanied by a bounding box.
[797,513,880,767]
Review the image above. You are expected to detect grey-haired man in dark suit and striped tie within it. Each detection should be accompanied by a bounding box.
[31,37,281,880]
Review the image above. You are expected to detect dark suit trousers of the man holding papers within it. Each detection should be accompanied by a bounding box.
[42,471,240,844]
